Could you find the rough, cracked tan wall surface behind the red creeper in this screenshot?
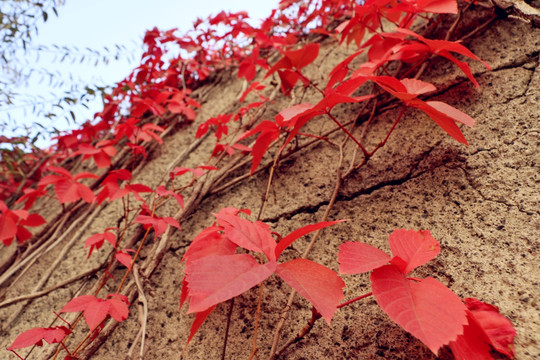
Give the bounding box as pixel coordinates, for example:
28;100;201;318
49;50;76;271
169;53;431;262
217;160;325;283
0;8;540;360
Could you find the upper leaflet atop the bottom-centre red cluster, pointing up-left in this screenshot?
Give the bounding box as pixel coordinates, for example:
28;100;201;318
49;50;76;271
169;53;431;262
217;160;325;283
216;214;276;261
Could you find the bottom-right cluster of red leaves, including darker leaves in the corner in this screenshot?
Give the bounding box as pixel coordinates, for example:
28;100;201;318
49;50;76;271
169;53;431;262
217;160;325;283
338;230;515;359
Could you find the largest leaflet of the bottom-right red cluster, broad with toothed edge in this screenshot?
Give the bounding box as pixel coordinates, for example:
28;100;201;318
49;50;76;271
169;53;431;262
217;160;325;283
370;265;467;354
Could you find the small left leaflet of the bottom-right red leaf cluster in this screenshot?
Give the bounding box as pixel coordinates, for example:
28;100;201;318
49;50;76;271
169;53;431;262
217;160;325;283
338;241;390;274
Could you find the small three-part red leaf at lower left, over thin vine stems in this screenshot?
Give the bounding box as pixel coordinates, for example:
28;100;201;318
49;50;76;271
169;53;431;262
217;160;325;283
60;294;129;331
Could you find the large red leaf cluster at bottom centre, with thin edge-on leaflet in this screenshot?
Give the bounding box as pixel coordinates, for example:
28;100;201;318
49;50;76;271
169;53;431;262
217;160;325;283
181;209;344;341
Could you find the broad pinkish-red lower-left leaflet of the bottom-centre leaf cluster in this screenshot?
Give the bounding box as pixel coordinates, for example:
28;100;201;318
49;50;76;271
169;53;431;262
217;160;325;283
186;254;276;313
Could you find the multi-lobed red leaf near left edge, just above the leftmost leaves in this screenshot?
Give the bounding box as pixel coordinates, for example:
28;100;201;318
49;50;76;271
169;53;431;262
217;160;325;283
38;166;99;204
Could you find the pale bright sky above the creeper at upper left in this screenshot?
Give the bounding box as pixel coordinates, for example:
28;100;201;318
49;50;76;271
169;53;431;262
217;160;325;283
5;0;279;143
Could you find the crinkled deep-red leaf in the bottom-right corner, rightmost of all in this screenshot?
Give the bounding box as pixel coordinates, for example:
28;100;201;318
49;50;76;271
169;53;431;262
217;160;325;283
464;298;516;358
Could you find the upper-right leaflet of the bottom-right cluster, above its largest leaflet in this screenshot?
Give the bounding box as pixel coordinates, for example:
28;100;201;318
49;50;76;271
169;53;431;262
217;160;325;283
388;229;441;275
